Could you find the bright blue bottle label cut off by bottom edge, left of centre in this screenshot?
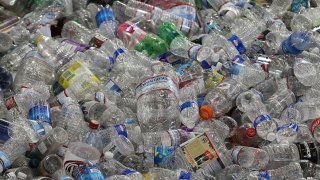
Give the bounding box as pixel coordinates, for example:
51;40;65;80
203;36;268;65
72;165;104;180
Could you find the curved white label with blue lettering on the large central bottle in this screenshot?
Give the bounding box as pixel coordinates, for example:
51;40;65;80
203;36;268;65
136;75;179;99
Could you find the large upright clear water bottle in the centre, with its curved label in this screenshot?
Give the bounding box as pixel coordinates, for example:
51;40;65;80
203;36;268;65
136;66;180;132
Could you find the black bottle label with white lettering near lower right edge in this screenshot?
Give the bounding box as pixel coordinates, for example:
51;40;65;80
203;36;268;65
296;142;318;164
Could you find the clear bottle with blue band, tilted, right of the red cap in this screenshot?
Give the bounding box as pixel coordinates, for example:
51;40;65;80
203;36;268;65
236;90;277;141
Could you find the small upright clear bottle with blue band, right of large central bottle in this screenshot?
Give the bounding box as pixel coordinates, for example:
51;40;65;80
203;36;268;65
179;82;200;128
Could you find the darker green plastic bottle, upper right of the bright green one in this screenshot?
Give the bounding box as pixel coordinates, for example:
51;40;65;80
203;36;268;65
158;22;187;45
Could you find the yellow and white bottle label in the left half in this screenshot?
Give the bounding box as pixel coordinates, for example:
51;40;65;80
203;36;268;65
59;61;100;91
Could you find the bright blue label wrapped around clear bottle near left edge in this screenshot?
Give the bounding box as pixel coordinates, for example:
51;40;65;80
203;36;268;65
29;103;52;124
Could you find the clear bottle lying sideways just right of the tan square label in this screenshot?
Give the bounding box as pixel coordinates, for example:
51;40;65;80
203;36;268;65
231;146;269;170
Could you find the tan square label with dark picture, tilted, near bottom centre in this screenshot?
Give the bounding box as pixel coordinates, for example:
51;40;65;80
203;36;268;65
180;133;225;171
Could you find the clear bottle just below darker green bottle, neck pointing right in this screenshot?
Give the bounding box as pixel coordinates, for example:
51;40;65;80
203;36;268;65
170;37;219;64
